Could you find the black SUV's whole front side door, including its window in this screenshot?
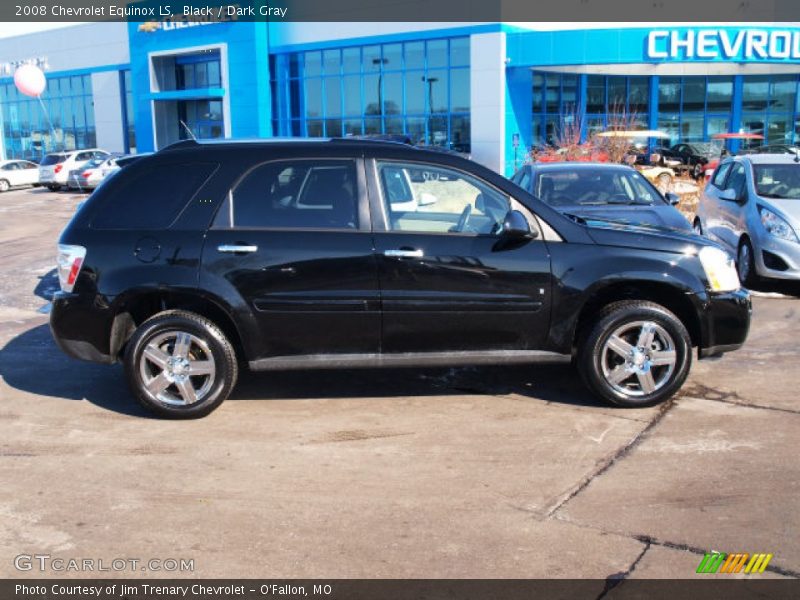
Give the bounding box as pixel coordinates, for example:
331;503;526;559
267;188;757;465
370;160;550;353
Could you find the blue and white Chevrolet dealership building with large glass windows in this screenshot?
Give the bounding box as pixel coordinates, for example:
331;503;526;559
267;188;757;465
0;20;800;174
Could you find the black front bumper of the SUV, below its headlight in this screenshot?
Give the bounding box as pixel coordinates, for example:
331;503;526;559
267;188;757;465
697;289;753;359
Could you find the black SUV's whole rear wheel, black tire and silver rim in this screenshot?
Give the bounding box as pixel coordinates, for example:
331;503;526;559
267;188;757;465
124;310;238;419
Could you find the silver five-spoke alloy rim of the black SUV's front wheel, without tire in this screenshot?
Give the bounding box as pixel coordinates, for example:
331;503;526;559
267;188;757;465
600;321;678;396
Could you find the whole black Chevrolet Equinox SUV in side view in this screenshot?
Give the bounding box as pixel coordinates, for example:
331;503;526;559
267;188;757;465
50;139;750;417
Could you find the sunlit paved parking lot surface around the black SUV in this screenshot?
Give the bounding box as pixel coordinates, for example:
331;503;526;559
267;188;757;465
0;189;800;590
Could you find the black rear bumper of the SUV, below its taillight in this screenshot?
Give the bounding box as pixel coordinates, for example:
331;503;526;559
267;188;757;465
50;292;116;364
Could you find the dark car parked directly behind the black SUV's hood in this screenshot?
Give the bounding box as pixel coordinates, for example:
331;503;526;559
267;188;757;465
512;162;691;232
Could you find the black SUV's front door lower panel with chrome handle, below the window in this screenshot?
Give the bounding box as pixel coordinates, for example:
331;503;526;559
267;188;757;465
375;232;550;352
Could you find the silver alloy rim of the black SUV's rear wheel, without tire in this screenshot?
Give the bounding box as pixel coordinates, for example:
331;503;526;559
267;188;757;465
139;331;217;406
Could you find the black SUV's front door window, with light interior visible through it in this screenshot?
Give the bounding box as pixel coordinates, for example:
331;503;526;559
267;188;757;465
377;161;511;235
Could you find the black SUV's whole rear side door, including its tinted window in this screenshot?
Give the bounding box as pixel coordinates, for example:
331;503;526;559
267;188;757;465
200;160;380;360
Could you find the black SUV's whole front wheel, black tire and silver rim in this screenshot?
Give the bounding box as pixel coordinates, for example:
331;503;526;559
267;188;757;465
577;300;692;408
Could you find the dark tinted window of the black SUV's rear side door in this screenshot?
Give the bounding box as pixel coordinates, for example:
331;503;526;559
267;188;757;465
230;160;358;229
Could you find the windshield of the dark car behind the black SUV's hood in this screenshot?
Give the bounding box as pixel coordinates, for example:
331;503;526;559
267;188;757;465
534;168;663;206
